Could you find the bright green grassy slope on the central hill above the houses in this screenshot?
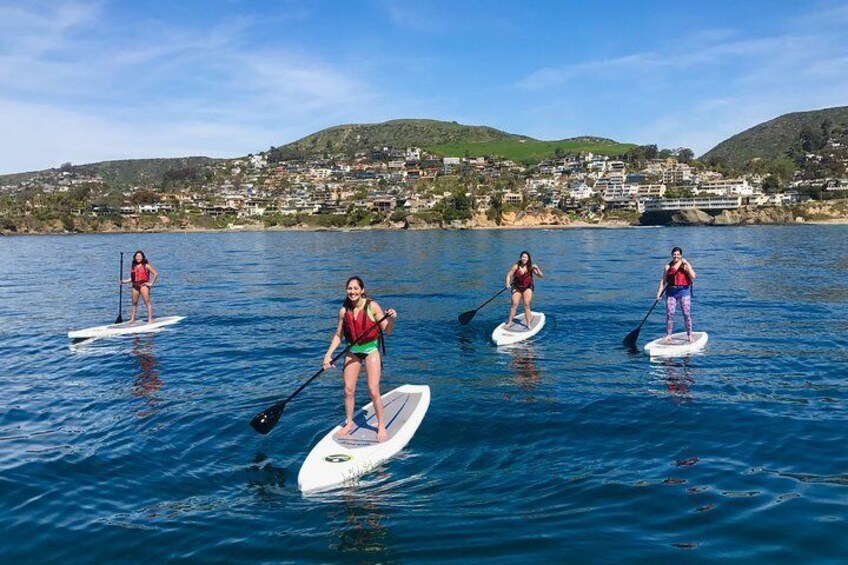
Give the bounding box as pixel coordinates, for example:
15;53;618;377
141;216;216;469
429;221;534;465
426;137;636;161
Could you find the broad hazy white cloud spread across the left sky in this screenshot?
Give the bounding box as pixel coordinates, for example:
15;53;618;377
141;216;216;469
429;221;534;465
0;2;380;172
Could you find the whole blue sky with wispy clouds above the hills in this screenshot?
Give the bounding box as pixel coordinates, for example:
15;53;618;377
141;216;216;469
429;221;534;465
0;0;848;173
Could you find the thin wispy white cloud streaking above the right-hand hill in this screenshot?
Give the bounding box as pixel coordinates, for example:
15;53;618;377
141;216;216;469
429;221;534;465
516;8;848;153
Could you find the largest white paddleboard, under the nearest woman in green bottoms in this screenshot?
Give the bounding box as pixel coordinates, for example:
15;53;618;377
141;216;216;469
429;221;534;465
297;385;430;492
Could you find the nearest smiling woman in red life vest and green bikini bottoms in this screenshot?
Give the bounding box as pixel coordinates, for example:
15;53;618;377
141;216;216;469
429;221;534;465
324;277;397;441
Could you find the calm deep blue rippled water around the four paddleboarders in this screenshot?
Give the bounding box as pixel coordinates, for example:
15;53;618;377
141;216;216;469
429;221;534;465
0;226;848;563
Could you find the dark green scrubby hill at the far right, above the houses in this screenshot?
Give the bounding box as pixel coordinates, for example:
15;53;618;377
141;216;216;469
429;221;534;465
701;106;848;167
